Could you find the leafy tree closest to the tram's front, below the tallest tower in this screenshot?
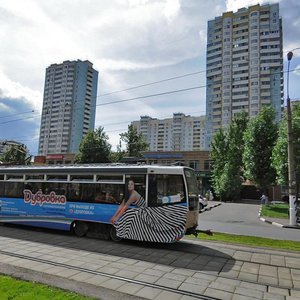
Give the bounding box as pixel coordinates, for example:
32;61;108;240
210;112;248;201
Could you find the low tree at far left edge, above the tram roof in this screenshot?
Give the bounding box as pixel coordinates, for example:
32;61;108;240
0;145;32;165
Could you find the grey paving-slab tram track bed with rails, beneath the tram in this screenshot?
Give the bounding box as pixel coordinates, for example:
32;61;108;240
0;226;300;300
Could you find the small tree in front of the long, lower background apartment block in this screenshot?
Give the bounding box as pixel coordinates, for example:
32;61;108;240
120;124;148;157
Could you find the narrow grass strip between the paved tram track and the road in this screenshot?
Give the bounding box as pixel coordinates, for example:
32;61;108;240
187;232;300;251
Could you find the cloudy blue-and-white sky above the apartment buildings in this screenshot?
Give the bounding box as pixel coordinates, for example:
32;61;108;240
0;0;300;155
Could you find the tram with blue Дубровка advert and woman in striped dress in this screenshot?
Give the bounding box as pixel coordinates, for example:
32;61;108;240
0;164;199;243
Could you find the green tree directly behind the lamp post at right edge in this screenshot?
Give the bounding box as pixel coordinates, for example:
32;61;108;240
272;103;300;185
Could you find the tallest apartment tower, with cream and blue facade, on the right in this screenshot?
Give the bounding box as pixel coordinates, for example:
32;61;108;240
206;4;283;148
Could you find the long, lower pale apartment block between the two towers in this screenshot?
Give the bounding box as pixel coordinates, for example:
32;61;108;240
132;113;205;151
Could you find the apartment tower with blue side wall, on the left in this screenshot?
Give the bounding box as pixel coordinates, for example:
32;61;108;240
38;60;98;155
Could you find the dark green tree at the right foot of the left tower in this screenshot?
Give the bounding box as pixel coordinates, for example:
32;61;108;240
75;126;111;163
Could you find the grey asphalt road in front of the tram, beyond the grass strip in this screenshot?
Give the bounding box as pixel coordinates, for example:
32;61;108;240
198;202;300;241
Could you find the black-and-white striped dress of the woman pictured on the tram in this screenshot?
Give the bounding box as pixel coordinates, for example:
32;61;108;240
116;197;187;243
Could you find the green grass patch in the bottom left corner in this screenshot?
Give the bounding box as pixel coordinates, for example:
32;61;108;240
0;275;93;300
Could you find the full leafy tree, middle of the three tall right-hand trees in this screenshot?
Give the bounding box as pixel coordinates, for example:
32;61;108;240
243;106;278;191
